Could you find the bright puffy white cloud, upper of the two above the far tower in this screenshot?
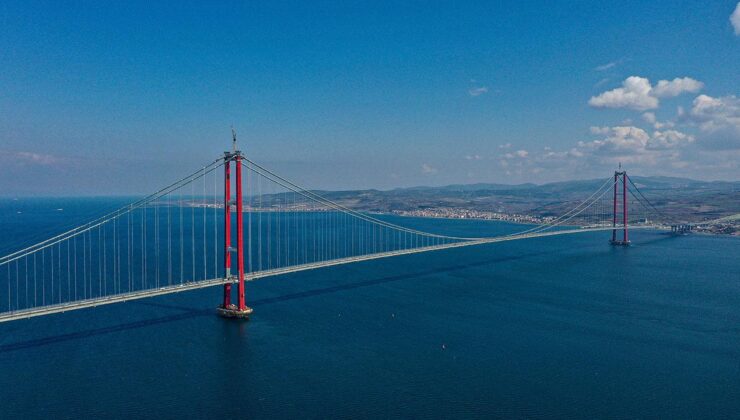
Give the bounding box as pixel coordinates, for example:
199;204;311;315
588;76;704;111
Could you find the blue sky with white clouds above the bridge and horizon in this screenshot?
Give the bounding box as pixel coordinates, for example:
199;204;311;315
0;0;740;196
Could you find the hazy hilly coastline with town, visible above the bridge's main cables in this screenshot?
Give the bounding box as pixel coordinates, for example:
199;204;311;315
306;176;740;221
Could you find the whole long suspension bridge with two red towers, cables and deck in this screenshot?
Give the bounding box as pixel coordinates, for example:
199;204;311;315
0;139;720;322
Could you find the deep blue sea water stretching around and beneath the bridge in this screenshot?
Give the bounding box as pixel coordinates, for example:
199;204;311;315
0;199;740;418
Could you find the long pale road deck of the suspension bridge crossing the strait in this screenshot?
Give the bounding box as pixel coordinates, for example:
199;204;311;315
0;225;665;322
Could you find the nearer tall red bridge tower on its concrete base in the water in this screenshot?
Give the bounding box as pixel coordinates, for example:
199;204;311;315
217;144;252;319
